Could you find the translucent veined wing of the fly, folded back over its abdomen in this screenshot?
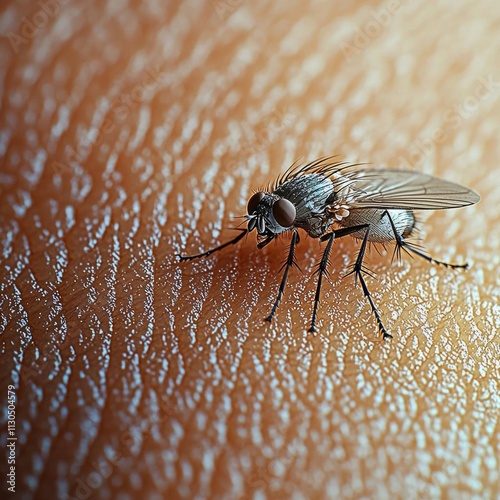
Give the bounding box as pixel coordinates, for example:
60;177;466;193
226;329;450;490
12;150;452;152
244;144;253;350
339;169;479;210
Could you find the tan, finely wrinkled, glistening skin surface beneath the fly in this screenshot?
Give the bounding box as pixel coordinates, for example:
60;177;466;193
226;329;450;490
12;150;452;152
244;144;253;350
0;0;500;498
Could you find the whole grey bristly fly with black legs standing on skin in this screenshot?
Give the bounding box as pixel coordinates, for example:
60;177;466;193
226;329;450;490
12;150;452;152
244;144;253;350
178;157;479;339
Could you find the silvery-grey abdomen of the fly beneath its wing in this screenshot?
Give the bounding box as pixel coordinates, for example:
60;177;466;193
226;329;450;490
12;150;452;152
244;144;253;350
340;208;415;243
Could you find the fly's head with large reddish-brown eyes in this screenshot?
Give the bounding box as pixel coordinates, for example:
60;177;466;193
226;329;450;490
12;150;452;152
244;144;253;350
246;191;297;240
